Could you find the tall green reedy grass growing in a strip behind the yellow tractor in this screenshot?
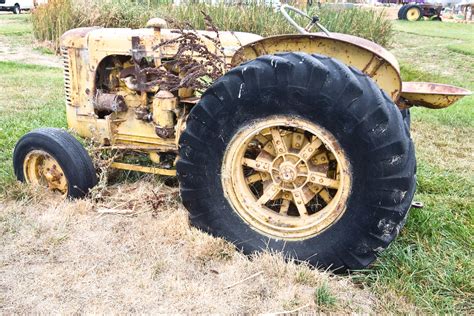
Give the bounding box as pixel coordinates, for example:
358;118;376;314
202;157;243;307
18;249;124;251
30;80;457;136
32;0;393;49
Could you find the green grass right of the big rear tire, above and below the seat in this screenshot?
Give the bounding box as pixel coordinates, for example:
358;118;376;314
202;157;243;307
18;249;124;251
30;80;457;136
356;21;474;314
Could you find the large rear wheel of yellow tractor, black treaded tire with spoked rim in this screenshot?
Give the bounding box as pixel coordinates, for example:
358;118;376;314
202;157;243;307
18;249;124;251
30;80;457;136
177;53;416;271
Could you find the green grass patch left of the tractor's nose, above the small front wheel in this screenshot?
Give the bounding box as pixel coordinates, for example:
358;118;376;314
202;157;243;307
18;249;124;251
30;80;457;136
0;62;66;193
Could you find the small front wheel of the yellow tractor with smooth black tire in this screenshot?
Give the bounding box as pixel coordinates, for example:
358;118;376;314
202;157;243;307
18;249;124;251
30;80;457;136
13;128;97;198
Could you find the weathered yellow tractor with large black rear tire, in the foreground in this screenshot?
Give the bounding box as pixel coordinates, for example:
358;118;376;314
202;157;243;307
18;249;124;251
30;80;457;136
14;5;470;270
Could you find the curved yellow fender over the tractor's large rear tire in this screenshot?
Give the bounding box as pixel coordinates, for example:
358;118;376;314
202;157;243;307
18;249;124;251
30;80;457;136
231;33;402;102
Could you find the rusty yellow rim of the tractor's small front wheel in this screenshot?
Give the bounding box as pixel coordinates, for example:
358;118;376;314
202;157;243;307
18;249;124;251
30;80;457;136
23;150;68;194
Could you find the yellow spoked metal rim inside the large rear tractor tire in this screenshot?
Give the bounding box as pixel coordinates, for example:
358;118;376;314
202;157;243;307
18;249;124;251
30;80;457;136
222;117;351;240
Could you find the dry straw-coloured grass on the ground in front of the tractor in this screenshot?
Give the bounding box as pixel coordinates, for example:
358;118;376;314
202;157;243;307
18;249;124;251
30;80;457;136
0;182;402;313
